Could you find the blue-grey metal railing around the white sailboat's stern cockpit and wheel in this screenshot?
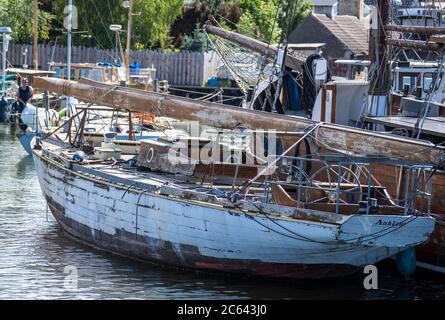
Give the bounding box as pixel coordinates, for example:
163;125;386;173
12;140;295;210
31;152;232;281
264;155;433;215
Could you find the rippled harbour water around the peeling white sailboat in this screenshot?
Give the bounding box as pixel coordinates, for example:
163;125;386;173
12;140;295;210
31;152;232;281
0;124;445;299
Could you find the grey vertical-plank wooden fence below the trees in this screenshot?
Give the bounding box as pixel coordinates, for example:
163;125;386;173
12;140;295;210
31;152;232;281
3;43;218;86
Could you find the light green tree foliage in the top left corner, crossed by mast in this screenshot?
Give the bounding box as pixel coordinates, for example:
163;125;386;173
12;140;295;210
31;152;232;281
0;0;55;43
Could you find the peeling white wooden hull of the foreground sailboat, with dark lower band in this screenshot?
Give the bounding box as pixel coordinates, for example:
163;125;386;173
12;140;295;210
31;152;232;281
34;146;434;279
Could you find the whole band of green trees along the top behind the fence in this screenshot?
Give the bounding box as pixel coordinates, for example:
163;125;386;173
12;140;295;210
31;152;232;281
0;0;312;51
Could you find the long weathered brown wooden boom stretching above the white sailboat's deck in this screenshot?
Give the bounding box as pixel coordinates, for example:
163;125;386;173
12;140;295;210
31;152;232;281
34;78;445;164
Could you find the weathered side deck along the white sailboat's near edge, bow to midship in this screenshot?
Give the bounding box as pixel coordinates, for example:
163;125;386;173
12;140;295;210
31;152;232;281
35;143;349;225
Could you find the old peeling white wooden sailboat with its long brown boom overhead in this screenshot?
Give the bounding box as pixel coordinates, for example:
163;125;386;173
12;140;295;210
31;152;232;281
29;78;444;278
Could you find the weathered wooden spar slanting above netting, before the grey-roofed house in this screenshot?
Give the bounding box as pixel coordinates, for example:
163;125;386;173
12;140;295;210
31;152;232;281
204;25;306;71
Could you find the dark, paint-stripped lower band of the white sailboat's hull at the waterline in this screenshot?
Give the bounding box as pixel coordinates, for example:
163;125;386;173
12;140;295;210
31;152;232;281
47;198;358;279
